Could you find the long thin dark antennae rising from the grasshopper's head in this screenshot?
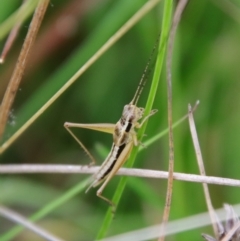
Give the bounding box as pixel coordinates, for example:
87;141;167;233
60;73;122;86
130;35;160;105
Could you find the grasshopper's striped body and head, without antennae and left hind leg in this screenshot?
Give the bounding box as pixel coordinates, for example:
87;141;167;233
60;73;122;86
86;102;157;205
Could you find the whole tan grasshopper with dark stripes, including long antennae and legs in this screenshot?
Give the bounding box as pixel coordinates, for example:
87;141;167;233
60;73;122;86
64;50;157;206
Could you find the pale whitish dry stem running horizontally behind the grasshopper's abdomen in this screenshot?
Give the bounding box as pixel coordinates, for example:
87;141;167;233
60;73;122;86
0;164;240;187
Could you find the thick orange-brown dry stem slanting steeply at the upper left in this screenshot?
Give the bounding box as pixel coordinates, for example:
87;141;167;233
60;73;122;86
0;0;49;139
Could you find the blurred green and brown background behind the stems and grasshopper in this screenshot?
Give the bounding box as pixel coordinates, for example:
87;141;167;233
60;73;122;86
0;0;240;241
